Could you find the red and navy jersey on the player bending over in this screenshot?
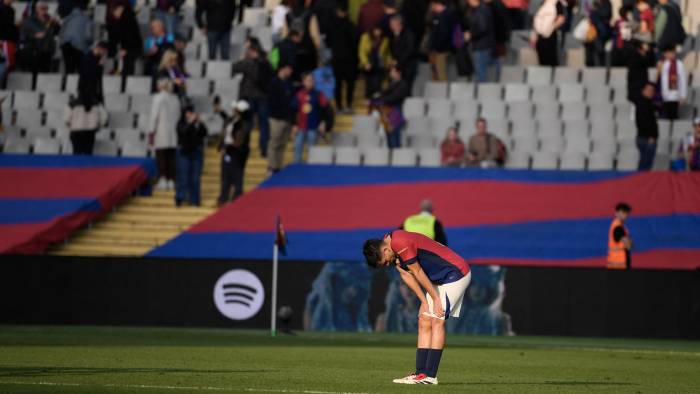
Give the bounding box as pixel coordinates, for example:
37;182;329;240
391;230;469;285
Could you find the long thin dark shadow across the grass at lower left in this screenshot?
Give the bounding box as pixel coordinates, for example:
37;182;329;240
0;366;276;377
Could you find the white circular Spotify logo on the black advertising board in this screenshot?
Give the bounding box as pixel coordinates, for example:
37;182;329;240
214;270;265;320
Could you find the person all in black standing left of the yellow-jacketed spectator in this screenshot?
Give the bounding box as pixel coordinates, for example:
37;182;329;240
329;6;358;114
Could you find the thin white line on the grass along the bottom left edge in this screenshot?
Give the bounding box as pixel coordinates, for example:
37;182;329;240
0;381;368;394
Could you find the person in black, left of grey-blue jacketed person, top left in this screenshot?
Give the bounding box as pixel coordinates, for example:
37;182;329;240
20;1;59;73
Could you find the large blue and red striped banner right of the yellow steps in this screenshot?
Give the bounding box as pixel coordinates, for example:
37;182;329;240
150;165;700;269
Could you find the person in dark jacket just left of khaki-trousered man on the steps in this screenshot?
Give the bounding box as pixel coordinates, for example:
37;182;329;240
233;44;273;157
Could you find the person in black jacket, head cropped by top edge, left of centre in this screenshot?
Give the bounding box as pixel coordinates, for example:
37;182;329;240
195;0;236;60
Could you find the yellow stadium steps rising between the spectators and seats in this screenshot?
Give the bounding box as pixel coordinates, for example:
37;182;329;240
47;88;367;256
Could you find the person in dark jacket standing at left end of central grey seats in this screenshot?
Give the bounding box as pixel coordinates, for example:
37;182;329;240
373;66;411;149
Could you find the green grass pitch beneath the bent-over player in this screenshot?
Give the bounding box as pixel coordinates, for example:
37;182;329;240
0;326;700;394
